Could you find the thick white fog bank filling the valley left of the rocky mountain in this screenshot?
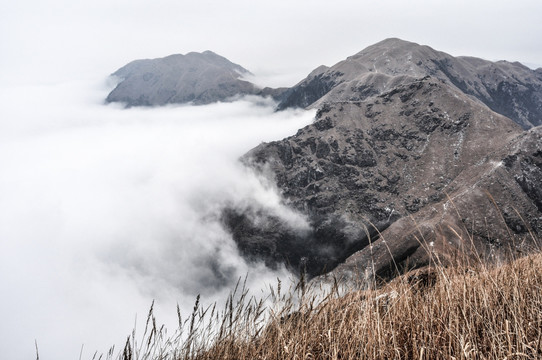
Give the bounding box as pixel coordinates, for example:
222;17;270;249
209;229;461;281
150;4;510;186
0;82;314;359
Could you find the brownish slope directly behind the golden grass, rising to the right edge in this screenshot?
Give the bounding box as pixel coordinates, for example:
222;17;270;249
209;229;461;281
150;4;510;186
332;126;542;278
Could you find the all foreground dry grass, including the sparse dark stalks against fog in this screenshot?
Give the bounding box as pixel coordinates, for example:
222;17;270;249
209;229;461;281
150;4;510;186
107;248;542;360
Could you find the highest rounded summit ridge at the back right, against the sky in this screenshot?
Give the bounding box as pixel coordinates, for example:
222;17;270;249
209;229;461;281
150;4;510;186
279;39;542;129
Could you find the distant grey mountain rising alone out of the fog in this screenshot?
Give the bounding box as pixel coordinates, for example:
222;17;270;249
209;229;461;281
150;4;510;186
106;51;268;107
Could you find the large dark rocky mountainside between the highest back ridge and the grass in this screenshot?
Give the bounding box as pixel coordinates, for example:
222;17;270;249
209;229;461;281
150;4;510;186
224;75;542;276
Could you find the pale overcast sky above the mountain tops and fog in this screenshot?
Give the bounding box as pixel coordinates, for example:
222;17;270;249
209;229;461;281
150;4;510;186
0;0;542;85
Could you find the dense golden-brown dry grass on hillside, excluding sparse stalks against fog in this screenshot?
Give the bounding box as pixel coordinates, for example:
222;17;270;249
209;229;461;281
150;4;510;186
196;256;542;359
